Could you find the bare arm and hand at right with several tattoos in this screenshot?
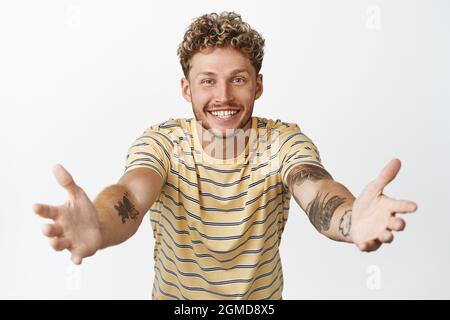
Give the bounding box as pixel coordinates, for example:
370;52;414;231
287;159;417;251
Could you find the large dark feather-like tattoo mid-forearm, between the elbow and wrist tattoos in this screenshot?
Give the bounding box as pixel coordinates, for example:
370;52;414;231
306;193;345;232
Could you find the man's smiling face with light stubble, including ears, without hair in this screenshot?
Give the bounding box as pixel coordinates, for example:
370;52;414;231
181;47;263;137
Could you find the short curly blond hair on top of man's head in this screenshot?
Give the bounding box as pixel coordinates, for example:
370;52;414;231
177;12;264;78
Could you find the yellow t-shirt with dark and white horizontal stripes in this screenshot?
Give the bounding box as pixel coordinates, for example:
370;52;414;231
125;117;322;299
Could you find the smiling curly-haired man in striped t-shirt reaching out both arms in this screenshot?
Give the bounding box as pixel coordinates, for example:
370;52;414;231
33;12;417;299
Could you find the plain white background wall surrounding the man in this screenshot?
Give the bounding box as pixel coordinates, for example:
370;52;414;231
0;0;450;299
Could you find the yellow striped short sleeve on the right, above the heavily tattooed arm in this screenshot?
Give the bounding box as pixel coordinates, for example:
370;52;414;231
280;124;323;187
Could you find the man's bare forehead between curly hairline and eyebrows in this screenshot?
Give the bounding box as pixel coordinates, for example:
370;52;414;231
190;47;254;77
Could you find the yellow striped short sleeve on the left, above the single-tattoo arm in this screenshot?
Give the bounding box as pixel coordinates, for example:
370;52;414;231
125;127;173;183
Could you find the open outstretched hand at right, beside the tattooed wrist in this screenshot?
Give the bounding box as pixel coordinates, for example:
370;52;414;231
350;159;417;251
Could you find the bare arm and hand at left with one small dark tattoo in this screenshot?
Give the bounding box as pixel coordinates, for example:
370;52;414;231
33;165;162;264
